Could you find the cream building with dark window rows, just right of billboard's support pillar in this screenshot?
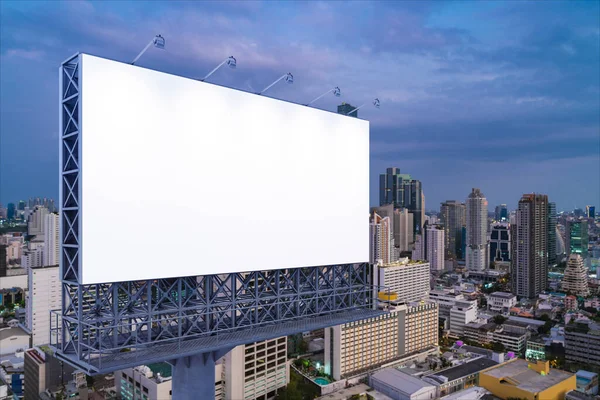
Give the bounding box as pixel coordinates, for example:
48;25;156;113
223;337;290;399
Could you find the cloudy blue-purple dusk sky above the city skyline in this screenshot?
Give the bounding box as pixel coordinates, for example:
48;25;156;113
0;0;600;210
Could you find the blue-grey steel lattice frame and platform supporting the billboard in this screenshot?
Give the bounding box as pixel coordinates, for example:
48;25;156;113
56;54;381;373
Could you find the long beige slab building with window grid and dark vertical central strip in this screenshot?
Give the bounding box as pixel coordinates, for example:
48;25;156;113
324;301;438;380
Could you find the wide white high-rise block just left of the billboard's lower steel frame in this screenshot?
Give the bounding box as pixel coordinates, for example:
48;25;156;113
25;265;61;346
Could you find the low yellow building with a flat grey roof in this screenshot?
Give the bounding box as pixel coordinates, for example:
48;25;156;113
479;359;577;400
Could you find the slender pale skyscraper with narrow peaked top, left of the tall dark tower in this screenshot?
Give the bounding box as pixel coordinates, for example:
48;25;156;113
465;188;489;271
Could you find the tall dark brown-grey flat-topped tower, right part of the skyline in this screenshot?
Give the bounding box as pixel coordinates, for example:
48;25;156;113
511;194;548;298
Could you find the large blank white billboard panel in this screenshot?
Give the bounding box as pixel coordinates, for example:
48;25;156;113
80;55;369;284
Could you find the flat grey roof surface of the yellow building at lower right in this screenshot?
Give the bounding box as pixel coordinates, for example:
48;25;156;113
484;358;573;393
